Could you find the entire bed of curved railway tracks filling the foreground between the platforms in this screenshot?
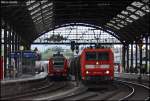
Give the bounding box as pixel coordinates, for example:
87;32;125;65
2;80;150;101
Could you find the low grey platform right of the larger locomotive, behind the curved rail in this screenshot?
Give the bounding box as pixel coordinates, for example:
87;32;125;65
114;72;150;81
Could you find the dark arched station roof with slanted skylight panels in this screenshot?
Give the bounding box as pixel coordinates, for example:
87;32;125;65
1;0;150;43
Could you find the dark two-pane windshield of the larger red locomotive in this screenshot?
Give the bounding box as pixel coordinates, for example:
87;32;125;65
86;52;109;60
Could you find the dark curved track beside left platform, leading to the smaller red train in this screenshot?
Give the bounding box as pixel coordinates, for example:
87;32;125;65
1;81;70;100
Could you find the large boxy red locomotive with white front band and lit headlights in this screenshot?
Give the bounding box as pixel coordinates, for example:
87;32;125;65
80;48;114;81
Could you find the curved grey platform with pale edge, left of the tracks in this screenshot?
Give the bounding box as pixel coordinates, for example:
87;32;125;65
1;72;48;98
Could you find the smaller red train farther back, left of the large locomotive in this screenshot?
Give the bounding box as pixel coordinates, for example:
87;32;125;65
48;52;68;79
